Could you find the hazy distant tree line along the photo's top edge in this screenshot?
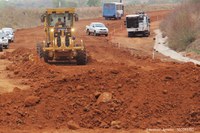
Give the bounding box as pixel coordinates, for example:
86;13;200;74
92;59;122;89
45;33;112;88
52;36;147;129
0;0;183;8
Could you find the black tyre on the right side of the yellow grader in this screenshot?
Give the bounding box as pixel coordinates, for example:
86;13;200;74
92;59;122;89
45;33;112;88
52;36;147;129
76;50;87;65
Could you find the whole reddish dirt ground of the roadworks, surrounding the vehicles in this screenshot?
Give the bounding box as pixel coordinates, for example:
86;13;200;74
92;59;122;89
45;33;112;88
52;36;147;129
0;11;200;133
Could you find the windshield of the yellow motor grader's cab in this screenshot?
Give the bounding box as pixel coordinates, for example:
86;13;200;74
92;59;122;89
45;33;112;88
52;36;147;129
48;13;73;28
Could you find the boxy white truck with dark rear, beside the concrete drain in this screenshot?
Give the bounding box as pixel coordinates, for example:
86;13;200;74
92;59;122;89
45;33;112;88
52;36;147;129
125;12;150;37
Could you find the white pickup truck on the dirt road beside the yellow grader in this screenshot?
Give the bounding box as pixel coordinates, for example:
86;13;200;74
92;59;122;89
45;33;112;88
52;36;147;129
86;22;109;36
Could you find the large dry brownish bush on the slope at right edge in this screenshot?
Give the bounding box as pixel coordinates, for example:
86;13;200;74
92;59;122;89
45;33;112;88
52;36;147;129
161;0;200;51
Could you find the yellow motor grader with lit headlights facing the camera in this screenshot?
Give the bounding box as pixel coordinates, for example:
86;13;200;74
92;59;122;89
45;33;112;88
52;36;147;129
37;8;87;65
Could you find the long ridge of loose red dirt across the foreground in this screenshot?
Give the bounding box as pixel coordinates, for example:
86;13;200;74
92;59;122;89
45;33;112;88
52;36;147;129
0;49;200;129
